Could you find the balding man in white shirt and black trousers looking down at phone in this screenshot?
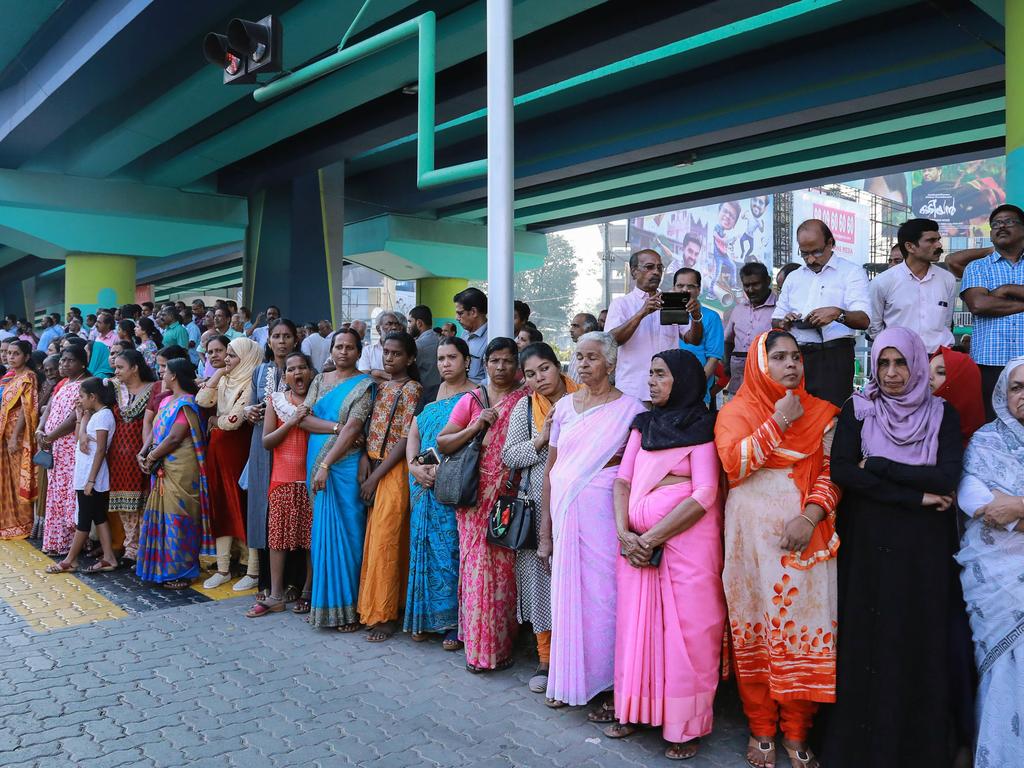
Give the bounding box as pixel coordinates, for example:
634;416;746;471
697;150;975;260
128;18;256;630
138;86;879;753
772;219;870;408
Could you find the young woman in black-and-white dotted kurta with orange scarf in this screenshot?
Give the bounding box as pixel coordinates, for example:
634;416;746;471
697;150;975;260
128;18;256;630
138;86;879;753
502;342;580;693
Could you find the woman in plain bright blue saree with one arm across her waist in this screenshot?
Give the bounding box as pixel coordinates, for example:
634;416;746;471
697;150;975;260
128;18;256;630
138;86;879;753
301;330;373;632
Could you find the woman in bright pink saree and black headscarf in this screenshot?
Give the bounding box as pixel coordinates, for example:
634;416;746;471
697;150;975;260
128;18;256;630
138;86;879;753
604;349;725;760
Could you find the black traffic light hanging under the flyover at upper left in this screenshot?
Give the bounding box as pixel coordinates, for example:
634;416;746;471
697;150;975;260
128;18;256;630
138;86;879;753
203;16;282;85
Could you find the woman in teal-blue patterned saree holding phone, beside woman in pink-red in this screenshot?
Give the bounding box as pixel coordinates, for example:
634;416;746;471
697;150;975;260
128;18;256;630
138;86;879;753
403;337;474;650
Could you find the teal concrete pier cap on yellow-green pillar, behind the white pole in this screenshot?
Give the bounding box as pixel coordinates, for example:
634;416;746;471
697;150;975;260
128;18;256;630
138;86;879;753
345;215;548;280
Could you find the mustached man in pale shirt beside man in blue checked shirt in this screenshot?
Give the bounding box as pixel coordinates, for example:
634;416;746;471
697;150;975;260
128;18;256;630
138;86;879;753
868;219;956;353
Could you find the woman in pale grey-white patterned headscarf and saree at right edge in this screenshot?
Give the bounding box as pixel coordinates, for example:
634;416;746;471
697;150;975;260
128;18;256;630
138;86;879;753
956;357;1024;768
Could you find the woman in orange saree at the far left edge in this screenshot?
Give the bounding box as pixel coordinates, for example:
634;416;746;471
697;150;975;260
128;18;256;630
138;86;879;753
0;341;39;539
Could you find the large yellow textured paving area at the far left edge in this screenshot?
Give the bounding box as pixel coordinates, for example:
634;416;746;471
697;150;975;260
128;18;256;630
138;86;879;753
0;541;128;632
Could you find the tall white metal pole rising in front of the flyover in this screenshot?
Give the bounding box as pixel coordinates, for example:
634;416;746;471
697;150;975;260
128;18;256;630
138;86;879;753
487;0;514;339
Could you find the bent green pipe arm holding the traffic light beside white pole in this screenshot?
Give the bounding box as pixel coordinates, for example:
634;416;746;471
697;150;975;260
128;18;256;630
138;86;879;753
253;11;487;189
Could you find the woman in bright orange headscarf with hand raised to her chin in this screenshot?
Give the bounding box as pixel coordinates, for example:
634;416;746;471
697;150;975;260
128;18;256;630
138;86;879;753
715;331;839;768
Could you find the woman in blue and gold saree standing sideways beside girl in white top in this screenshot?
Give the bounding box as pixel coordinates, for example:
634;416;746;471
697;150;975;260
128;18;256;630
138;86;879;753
135;359;216;589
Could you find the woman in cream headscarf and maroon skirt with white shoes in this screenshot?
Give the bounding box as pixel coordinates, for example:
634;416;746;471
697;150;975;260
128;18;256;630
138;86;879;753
196;338;263;591
